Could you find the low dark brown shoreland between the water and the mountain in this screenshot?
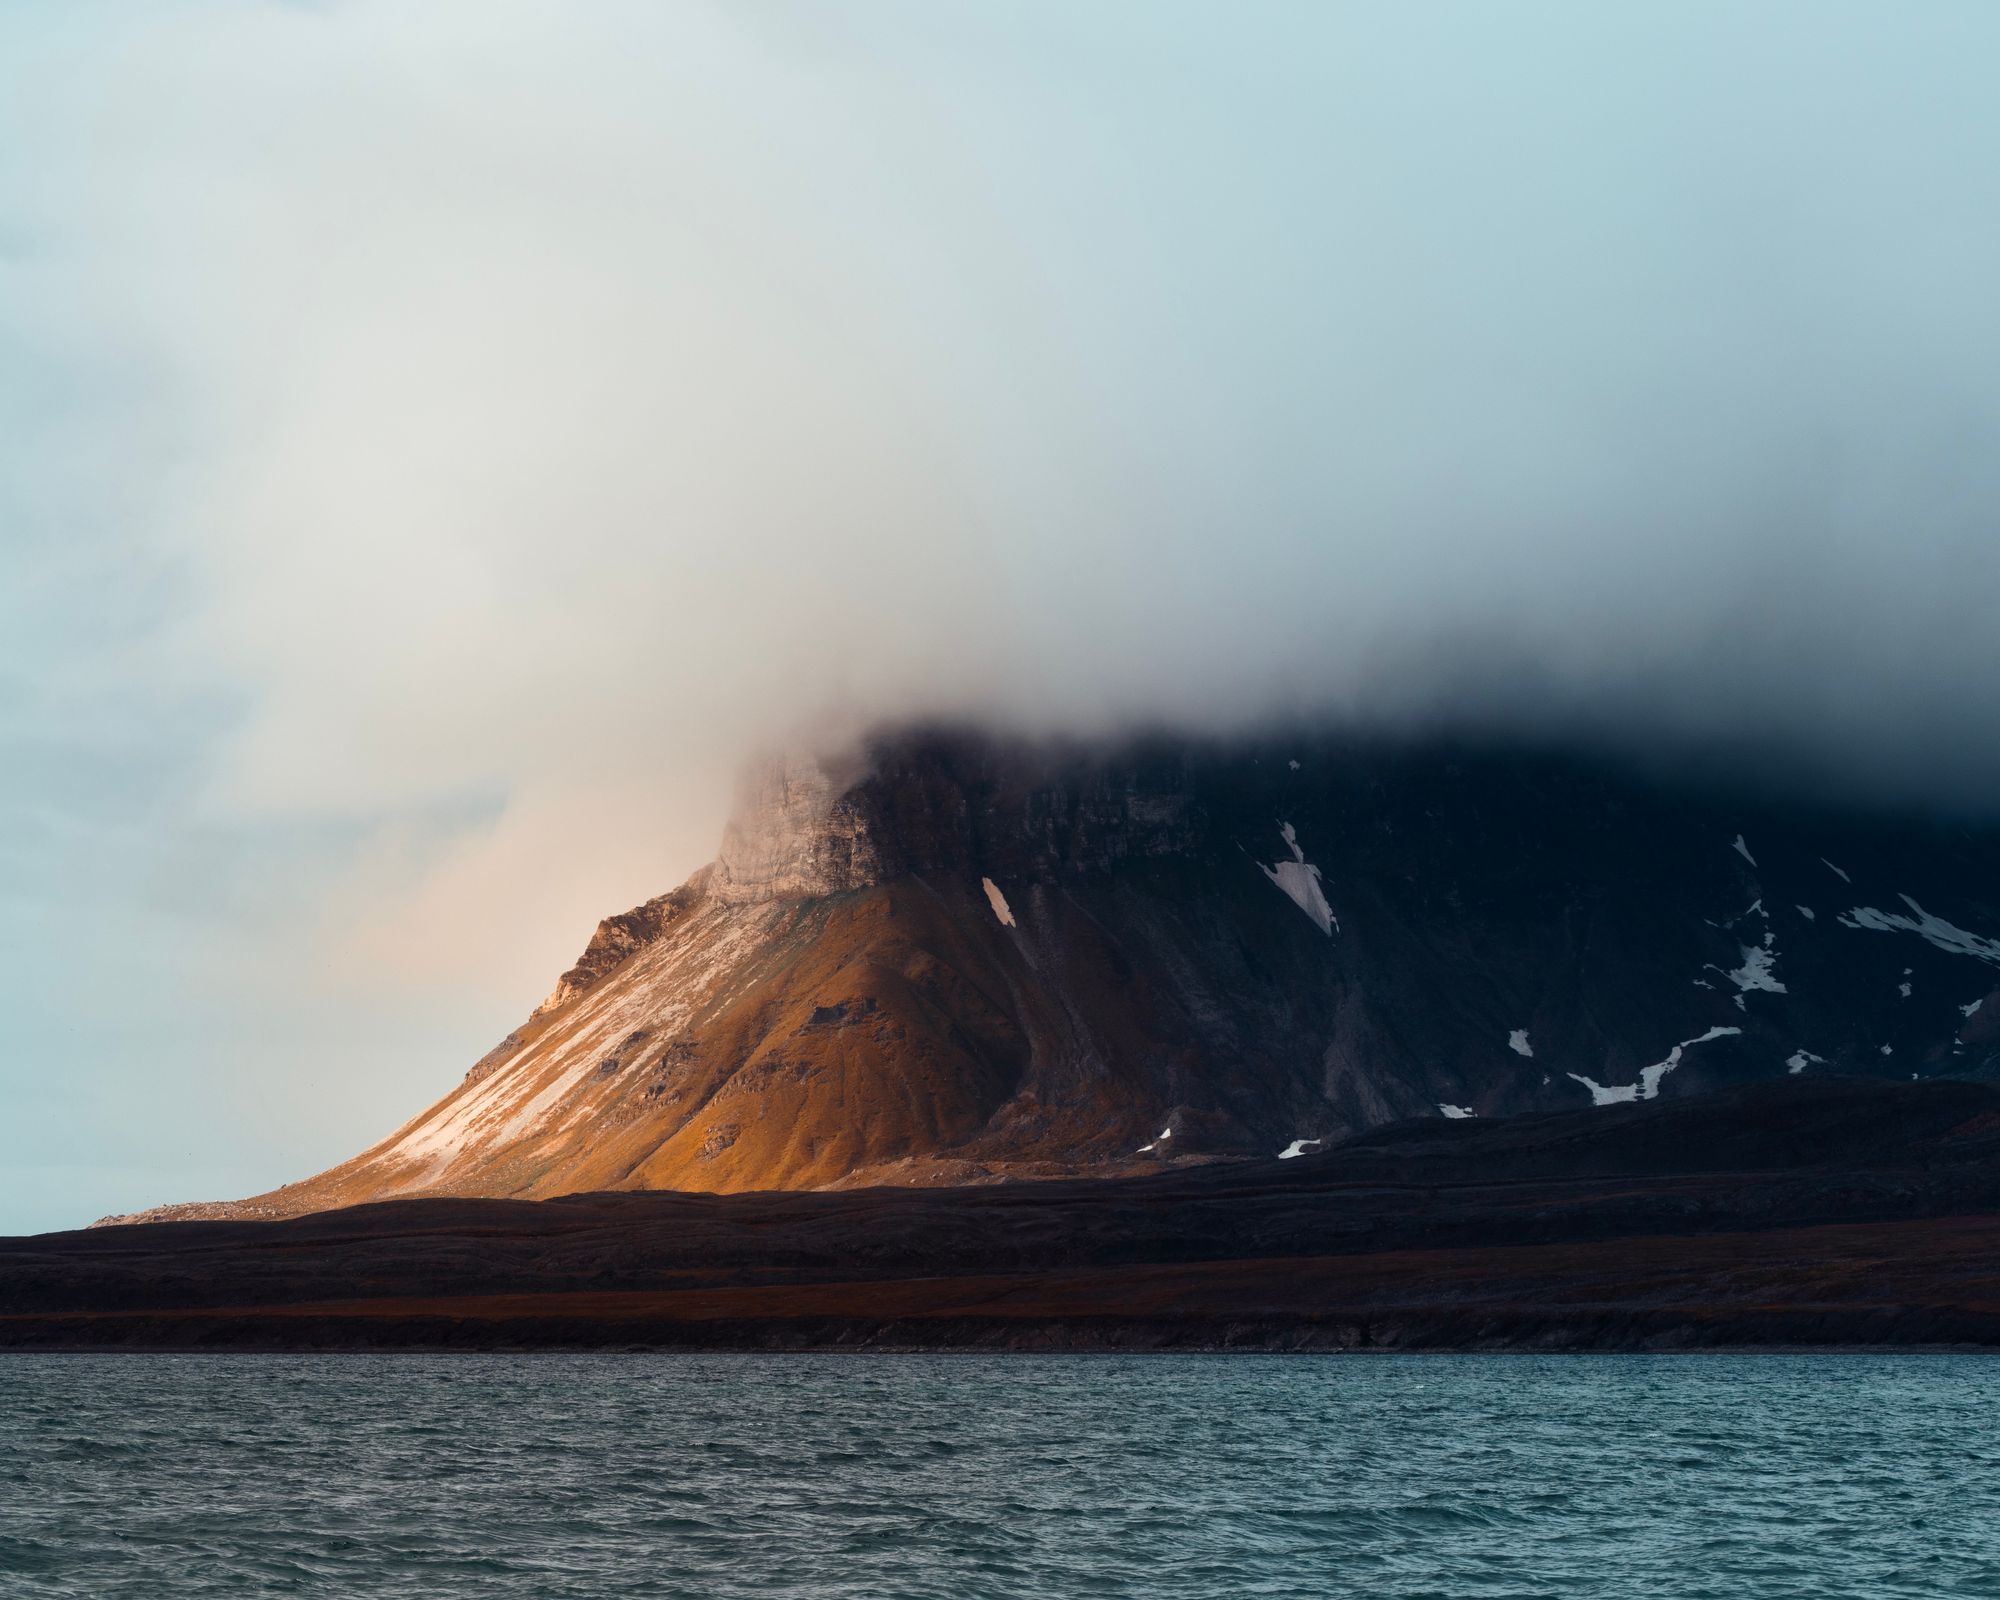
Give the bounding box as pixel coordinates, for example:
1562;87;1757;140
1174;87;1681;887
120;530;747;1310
11;1080;2000;1350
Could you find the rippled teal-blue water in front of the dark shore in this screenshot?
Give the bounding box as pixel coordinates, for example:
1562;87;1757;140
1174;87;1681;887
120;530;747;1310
0;1356;2000;1600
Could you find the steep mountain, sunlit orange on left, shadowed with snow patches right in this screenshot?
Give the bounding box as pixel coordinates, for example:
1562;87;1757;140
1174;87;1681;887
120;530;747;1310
108;728;2000;1220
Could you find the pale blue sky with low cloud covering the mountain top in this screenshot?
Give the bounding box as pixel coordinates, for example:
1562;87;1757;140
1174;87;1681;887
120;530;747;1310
0;0;2000;1226
